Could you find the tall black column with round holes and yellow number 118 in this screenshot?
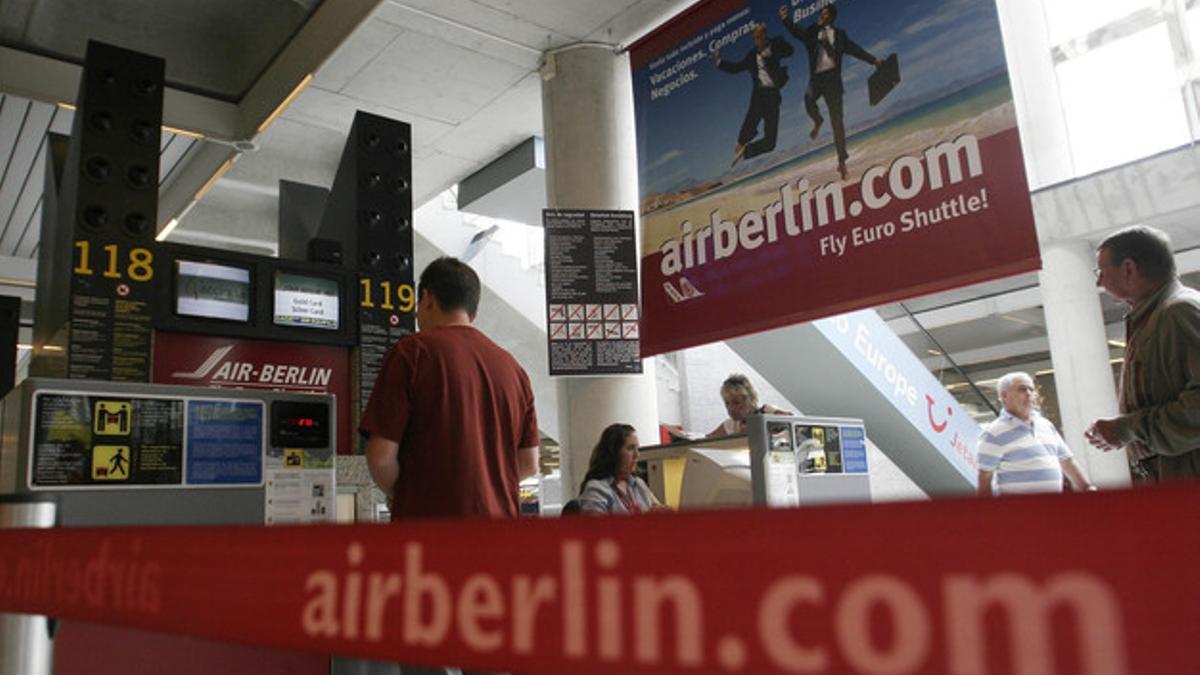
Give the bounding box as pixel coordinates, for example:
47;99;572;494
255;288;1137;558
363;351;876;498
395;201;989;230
54;41;164;382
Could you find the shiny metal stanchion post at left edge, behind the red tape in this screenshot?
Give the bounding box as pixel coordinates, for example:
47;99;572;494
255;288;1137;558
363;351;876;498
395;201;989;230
0;495;58;675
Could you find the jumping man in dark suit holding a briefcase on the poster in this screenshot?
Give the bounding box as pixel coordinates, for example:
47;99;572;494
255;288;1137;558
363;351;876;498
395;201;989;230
779;5;883;179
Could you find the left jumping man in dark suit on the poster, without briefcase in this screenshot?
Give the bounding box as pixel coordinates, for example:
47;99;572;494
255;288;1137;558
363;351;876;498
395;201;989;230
713;24;794;167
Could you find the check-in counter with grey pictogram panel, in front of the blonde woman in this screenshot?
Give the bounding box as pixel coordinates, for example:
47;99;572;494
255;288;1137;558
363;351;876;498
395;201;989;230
640;414;871;509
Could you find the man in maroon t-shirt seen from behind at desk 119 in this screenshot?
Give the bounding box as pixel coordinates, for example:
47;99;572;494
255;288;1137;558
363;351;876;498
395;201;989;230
359;257;539;520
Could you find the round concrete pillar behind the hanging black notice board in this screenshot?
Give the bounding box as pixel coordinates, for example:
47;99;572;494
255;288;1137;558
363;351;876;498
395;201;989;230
541;44;659;498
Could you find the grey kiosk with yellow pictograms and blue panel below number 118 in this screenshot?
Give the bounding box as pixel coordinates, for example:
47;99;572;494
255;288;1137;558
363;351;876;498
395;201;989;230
0;378;336;675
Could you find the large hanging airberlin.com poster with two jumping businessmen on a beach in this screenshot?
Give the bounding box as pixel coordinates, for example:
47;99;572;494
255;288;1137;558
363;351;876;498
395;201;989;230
630;0;1040;356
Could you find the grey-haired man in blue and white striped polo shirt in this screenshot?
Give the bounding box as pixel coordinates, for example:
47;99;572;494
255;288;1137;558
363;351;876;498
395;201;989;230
976;372;1096;497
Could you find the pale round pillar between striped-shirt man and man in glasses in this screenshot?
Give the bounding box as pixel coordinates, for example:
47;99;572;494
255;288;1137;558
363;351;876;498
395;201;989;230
1040;239;1129;488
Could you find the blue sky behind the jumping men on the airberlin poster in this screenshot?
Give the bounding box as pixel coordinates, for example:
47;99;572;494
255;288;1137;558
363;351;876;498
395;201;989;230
634;0;1006;198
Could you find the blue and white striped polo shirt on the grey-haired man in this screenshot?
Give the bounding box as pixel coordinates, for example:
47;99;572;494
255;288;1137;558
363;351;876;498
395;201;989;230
976;411;1072;495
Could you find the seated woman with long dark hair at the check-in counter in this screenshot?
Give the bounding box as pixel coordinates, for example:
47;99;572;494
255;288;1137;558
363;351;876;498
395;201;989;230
578;424;667;514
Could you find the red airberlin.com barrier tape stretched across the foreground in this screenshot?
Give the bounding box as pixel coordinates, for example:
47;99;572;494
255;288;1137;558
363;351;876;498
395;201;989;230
0;485;1200;675
